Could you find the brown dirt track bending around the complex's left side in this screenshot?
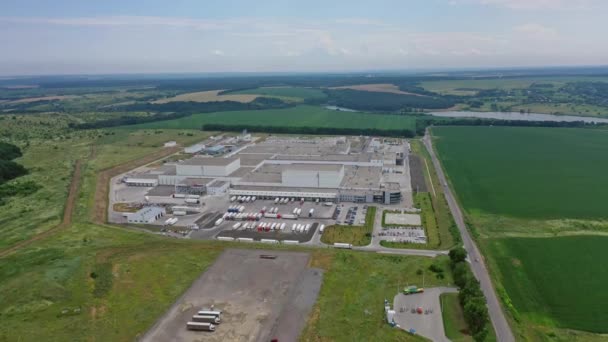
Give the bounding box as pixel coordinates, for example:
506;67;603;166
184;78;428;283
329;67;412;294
91;146;181;224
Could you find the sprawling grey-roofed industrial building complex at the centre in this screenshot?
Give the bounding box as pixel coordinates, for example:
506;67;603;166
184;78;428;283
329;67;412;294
125;137;411;204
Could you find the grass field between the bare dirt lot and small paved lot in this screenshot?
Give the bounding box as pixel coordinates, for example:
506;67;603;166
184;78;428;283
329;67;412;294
300;251;453;341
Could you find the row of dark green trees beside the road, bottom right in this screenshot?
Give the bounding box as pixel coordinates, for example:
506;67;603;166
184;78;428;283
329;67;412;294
449;247;490;341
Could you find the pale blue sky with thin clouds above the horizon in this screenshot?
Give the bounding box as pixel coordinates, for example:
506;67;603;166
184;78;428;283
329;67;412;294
0;0;608;75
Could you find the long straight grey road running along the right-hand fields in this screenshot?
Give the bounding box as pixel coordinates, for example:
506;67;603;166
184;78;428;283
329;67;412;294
422;129;515;342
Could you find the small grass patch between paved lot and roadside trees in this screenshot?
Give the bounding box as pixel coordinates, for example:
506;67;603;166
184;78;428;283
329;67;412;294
440;293;476;342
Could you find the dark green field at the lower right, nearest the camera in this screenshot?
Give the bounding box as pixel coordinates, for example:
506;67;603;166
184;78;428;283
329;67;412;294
489;236;608;333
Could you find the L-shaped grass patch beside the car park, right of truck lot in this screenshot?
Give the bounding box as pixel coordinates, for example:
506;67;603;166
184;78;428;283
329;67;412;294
321;207;376;246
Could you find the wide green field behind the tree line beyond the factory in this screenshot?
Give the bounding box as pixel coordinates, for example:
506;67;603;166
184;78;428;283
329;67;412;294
128;106;415;130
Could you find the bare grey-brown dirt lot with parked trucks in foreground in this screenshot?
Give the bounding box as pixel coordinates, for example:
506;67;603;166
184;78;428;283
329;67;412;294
142;249;322;342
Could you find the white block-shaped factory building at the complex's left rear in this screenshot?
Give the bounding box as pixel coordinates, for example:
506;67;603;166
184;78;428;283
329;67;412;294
176;157;241;177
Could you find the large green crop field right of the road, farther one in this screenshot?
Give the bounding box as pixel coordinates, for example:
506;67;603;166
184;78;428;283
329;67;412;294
433;127;608;219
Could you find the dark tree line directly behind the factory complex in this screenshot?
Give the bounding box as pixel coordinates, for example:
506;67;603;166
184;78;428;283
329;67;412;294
201;124;415;138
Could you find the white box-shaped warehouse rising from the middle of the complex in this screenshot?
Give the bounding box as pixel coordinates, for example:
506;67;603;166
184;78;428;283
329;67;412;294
281;164;344;188
